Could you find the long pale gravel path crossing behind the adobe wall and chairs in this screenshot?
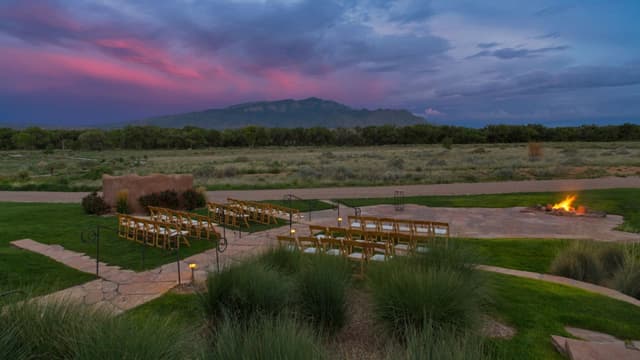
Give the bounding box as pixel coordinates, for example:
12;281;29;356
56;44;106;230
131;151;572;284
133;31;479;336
0;176;640;203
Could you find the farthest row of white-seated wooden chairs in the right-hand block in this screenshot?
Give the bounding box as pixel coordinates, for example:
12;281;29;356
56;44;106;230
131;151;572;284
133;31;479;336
347;216;450;238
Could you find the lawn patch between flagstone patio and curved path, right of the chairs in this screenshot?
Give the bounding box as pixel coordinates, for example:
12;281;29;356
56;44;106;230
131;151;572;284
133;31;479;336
453;238;572;273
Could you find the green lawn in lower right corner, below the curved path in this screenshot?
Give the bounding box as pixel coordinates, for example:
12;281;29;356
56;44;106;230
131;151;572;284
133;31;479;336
488;274;640;360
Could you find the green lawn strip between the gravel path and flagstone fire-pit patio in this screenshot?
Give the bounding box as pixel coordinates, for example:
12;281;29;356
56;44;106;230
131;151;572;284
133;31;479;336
335;189;640;232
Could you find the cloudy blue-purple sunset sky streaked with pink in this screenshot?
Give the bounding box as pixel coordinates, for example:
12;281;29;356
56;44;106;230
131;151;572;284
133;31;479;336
0;0;640;126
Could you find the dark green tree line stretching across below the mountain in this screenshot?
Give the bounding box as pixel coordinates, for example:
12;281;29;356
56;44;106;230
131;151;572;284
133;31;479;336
0;124;640;150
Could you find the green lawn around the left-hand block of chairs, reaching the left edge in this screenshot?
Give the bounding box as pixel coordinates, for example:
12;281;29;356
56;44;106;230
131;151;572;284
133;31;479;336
0;203;215;272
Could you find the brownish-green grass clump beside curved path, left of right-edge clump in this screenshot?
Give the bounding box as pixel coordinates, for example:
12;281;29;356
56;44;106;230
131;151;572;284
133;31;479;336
550;242;603;284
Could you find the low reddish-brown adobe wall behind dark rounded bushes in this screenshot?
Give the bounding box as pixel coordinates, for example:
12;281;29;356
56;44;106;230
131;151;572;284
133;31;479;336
102;174;193;214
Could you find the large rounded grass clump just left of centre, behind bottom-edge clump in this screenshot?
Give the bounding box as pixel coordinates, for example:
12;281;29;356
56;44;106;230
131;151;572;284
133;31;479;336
201;261;293;320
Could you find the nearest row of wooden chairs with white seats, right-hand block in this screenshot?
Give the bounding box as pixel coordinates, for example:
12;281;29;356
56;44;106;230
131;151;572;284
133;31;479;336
277;236;393;276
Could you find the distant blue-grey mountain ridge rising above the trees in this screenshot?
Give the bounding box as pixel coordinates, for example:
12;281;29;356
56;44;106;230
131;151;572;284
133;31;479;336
133;97;425;129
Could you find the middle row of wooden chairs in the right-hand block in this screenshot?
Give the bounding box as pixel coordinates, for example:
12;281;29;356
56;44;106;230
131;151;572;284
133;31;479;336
309;225;440;255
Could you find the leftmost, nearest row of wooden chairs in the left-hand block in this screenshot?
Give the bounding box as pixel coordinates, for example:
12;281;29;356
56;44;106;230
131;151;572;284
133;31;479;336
118;214;191;249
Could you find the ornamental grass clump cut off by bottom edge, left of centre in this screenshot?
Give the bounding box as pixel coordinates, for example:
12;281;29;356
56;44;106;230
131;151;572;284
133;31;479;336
207;316;328;360
